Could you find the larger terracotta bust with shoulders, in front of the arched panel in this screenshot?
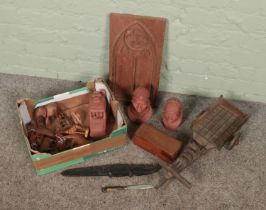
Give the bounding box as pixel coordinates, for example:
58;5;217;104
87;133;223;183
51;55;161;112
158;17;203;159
127;87;152;122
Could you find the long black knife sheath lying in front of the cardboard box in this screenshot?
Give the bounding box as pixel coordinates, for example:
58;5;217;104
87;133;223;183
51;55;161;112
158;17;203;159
61;164;161;177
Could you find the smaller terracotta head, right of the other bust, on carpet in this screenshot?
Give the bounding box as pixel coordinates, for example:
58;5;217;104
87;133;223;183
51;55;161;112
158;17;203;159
162;98;183;131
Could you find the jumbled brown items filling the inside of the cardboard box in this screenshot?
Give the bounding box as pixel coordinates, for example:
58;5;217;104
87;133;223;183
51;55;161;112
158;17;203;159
26;91;109;154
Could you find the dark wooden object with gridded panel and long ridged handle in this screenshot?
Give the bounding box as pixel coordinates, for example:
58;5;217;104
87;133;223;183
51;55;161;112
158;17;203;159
157;96;249;187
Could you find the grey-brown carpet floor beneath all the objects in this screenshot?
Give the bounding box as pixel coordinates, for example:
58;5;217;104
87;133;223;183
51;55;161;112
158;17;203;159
0;74;266;210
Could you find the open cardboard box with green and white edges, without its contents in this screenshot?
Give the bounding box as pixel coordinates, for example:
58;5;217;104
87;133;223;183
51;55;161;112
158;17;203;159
17;79;128;175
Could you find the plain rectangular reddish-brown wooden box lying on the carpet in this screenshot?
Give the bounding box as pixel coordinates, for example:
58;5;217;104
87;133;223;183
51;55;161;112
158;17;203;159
133;123;182;163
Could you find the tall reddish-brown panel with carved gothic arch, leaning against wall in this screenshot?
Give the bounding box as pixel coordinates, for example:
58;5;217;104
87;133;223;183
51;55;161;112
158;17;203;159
109;14;166;104
